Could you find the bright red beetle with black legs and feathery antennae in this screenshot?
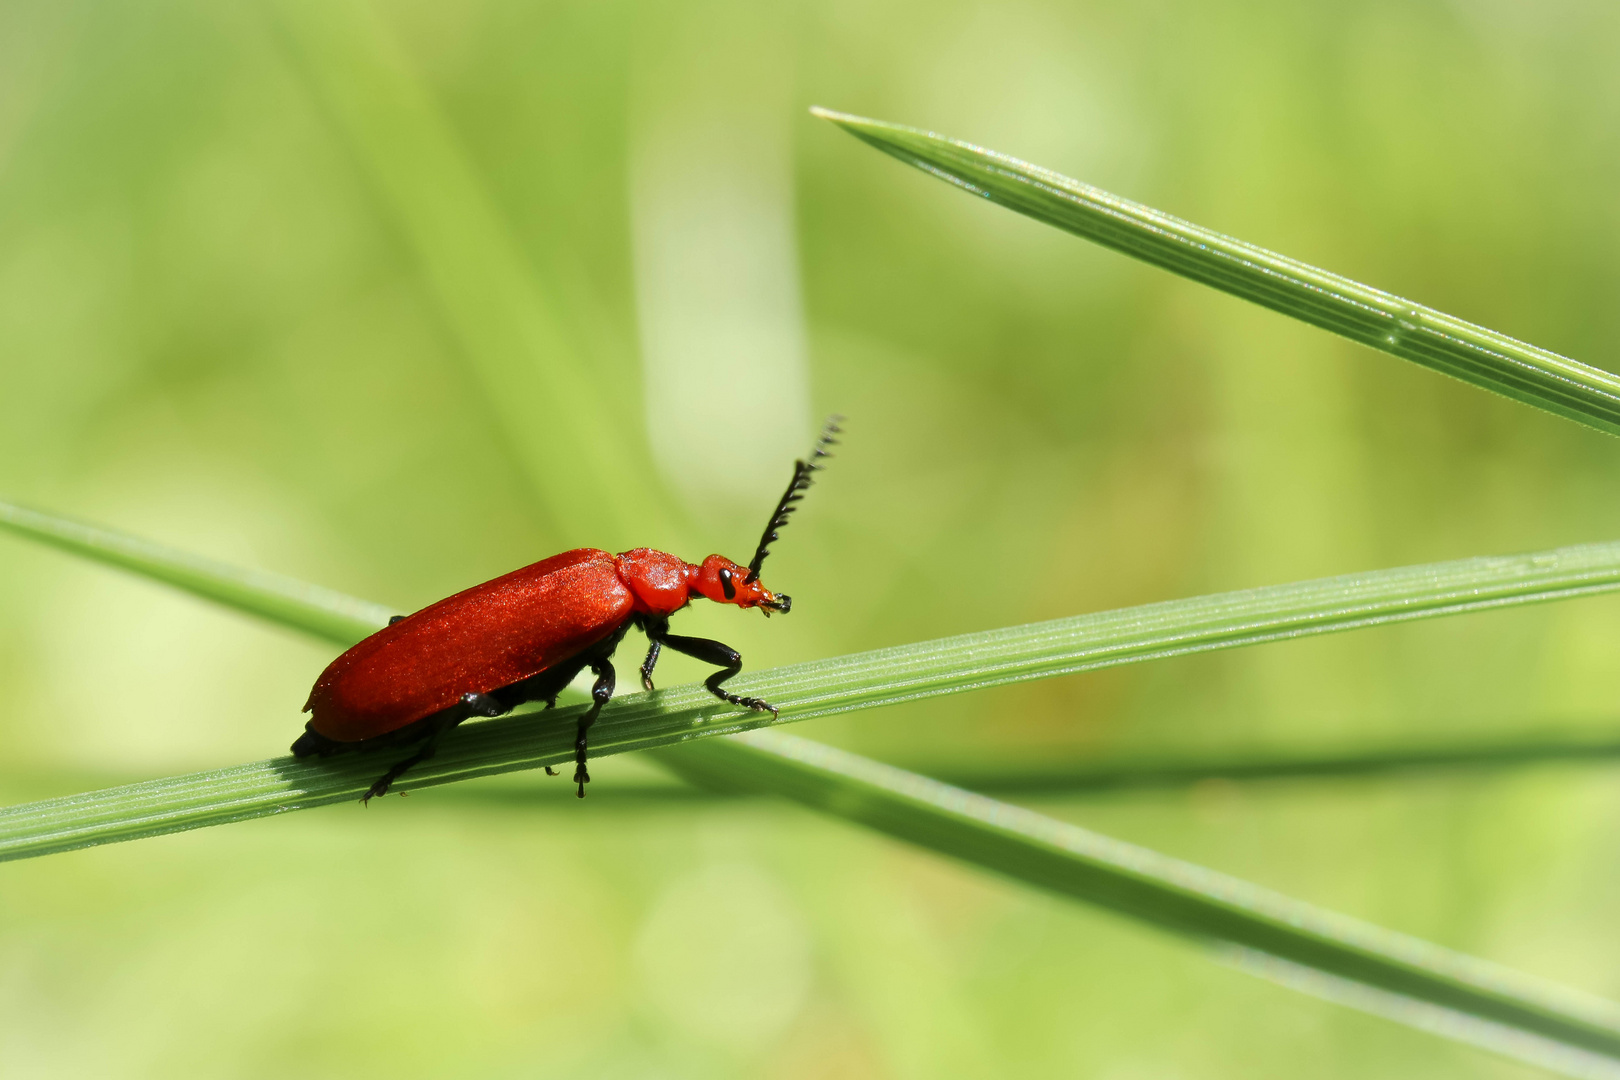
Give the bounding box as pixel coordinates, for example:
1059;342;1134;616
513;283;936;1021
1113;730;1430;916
292;416;842;801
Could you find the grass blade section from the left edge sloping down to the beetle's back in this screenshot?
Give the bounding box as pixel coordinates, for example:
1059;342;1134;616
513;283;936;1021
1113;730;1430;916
0;502;394;644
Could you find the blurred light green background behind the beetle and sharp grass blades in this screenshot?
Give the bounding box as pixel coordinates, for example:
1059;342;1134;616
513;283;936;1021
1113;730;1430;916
0;0;1620;1080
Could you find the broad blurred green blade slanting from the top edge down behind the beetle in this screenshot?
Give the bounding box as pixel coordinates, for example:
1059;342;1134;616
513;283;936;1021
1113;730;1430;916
269;0;663;537
